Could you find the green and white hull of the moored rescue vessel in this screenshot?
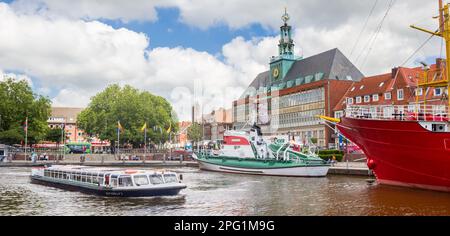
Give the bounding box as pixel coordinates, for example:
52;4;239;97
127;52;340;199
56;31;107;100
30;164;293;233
197;159;330;177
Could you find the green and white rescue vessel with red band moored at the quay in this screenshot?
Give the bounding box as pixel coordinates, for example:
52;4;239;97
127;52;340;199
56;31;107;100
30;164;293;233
193;125;330;177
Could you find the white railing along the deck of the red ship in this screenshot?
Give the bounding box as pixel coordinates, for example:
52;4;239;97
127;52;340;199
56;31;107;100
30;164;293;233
345;105;449;122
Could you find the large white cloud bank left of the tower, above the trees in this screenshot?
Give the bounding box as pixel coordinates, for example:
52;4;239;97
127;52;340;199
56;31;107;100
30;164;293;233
0;3;250;119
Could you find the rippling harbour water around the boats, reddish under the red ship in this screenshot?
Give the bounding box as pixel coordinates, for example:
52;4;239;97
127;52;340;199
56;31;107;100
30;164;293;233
0;168;450;216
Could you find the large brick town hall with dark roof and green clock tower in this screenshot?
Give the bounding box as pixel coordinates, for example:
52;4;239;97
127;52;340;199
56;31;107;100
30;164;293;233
233;10;364;147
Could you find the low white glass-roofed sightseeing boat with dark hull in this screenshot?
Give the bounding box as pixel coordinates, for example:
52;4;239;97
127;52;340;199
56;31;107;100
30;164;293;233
31;166;186;197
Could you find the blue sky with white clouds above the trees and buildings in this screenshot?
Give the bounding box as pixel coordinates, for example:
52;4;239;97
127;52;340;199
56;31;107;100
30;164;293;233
0;0;445;120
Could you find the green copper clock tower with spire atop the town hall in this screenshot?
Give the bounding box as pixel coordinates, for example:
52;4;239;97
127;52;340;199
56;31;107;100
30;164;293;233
270;9;301;84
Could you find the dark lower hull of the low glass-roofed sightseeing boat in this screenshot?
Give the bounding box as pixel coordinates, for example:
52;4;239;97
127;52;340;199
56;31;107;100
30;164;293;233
31;176;186;197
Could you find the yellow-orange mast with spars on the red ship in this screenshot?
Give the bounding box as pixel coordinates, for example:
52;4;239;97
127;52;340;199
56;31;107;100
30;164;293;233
411;0;450;117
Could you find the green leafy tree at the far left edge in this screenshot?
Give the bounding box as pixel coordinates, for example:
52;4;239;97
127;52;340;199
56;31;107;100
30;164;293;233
0;78;51;144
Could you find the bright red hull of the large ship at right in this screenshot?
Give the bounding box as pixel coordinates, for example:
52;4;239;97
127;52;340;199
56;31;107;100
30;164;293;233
337;117;450;192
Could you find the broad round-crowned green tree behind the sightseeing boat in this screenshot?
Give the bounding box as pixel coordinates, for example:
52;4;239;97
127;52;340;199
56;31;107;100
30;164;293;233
77;85;178;147
